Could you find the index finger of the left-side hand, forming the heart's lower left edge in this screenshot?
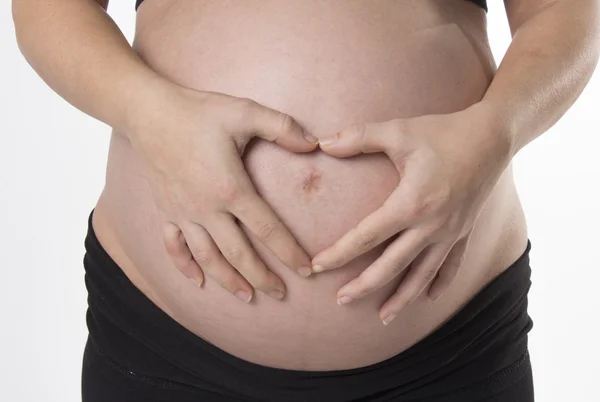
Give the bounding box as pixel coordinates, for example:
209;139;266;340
230;192;311;276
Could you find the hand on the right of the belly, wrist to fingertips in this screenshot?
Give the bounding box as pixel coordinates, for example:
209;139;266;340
312;106;510;324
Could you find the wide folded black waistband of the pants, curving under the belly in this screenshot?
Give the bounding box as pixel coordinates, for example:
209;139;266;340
84;212;532;402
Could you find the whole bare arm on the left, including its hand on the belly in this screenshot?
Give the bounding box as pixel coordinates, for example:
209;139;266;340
13;0;316;302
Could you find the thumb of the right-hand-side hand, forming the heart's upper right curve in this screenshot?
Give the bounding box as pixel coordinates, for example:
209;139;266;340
319;120;401;158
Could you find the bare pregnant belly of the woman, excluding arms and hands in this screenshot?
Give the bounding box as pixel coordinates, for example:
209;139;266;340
93;0;527;370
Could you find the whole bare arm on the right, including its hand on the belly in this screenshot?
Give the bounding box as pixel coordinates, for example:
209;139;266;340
312;0;600;324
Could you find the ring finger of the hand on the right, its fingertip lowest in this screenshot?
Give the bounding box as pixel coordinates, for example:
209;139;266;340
380;243;451;325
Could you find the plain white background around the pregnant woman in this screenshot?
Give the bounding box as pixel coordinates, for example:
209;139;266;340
0;0;600;402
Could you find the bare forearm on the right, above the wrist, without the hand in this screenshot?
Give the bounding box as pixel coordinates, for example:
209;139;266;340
481;0;599;156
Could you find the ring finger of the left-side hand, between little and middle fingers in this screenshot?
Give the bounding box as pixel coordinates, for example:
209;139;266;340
181;222;253;302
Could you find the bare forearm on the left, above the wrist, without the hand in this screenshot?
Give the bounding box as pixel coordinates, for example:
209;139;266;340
13;0;164;135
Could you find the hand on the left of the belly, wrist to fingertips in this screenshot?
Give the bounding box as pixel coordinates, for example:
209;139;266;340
129;83;317;302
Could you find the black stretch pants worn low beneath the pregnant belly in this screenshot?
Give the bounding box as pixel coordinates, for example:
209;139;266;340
82;215;534;402
